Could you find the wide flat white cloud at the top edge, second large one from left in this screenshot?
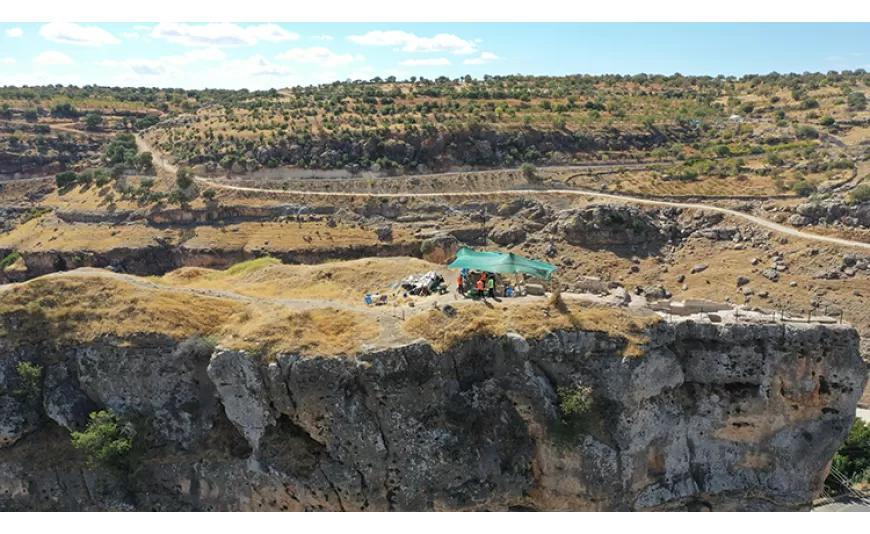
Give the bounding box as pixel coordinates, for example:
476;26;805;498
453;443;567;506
151;22;299;46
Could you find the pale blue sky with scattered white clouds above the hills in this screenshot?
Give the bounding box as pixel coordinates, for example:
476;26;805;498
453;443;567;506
0;22;870;90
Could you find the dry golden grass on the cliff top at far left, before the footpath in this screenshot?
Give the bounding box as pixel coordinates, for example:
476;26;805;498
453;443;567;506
0;276;380;355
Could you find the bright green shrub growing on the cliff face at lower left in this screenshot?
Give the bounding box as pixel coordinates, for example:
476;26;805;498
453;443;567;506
72;410;136;472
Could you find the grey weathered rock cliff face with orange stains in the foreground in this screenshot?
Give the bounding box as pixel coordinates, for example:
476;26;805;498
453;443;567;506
0;316;867;511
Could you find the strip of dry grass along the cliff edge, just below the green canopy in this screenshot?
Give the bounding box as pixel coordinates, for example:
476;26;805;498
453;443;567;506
405;302;659;356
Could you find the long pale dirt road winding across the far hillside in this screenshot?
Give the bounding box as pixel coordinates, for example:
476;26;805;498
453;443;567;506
136;136;870;250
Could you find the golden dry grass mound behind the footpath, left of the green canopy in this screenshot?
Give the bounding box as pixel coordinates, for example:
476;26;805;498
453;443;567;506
155;258;446;303
